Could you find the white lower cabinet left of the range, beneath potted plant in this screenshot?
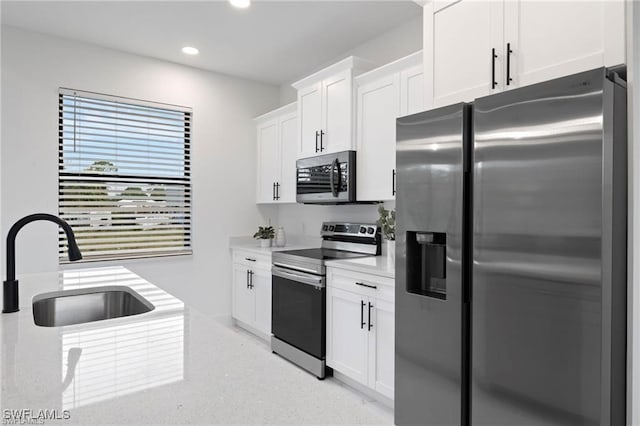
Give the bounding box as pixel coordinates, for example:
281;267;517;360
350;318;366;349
231;250;271;337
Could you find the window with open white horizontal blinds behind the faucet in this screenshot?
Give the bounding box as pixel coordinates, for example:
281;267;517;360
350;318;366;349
58;89;191;262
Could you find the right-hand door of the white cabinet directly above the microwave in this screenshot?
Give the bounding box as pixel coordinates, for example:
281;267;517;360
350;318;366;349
320;70;353;153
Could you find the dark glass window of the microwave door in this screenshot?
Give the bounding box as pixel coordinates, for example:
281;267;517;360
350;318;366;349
297;162;349;194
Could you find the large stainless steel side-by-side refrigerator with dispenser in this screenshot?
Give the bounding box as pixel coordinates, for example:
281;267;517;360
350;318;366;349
395;68;627;425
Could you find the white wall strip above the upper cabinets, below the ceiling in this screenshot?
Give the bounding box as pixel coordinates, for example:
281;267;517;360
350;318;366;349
280;14;422;105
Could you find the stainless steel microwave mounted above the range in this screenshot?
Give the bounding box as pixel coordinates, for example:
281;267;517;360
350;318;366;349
296;151;356;204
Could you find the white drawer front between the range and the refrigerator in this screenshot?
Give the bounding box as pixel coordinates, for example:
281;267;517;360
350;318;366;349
327;267;395;302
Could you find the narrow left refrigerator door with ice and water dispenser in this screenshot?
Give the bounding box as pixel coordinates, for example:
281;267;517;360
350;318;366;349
394;104;469;425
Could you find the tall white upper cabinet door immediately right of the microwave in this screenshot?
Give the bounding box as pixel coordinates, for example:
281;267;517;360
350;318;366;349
356;73;400;201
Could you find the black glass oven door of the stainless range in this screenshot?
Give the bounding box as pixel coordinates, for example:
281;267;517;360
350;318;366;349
271;266;326;359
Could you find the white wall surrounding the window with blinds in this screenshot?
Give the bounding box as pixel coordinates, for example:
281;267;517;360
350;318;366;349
1;27;279;315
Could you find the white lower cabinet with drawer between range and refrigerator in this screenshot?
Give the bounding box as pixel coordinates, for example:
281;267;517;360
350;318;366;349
327;267;395;399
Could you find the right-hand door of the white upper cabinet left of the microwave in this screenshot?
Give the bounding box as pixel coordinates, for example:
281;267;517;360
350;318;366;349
278;112;298;203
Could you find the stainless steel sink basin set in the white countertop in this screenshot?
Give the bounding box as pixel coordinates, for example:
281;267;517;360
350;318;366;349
33;286;154;327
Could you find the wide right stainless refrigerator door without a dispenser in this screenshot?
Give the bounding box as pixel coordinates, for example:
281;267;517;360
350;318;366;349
471;69;626;425
